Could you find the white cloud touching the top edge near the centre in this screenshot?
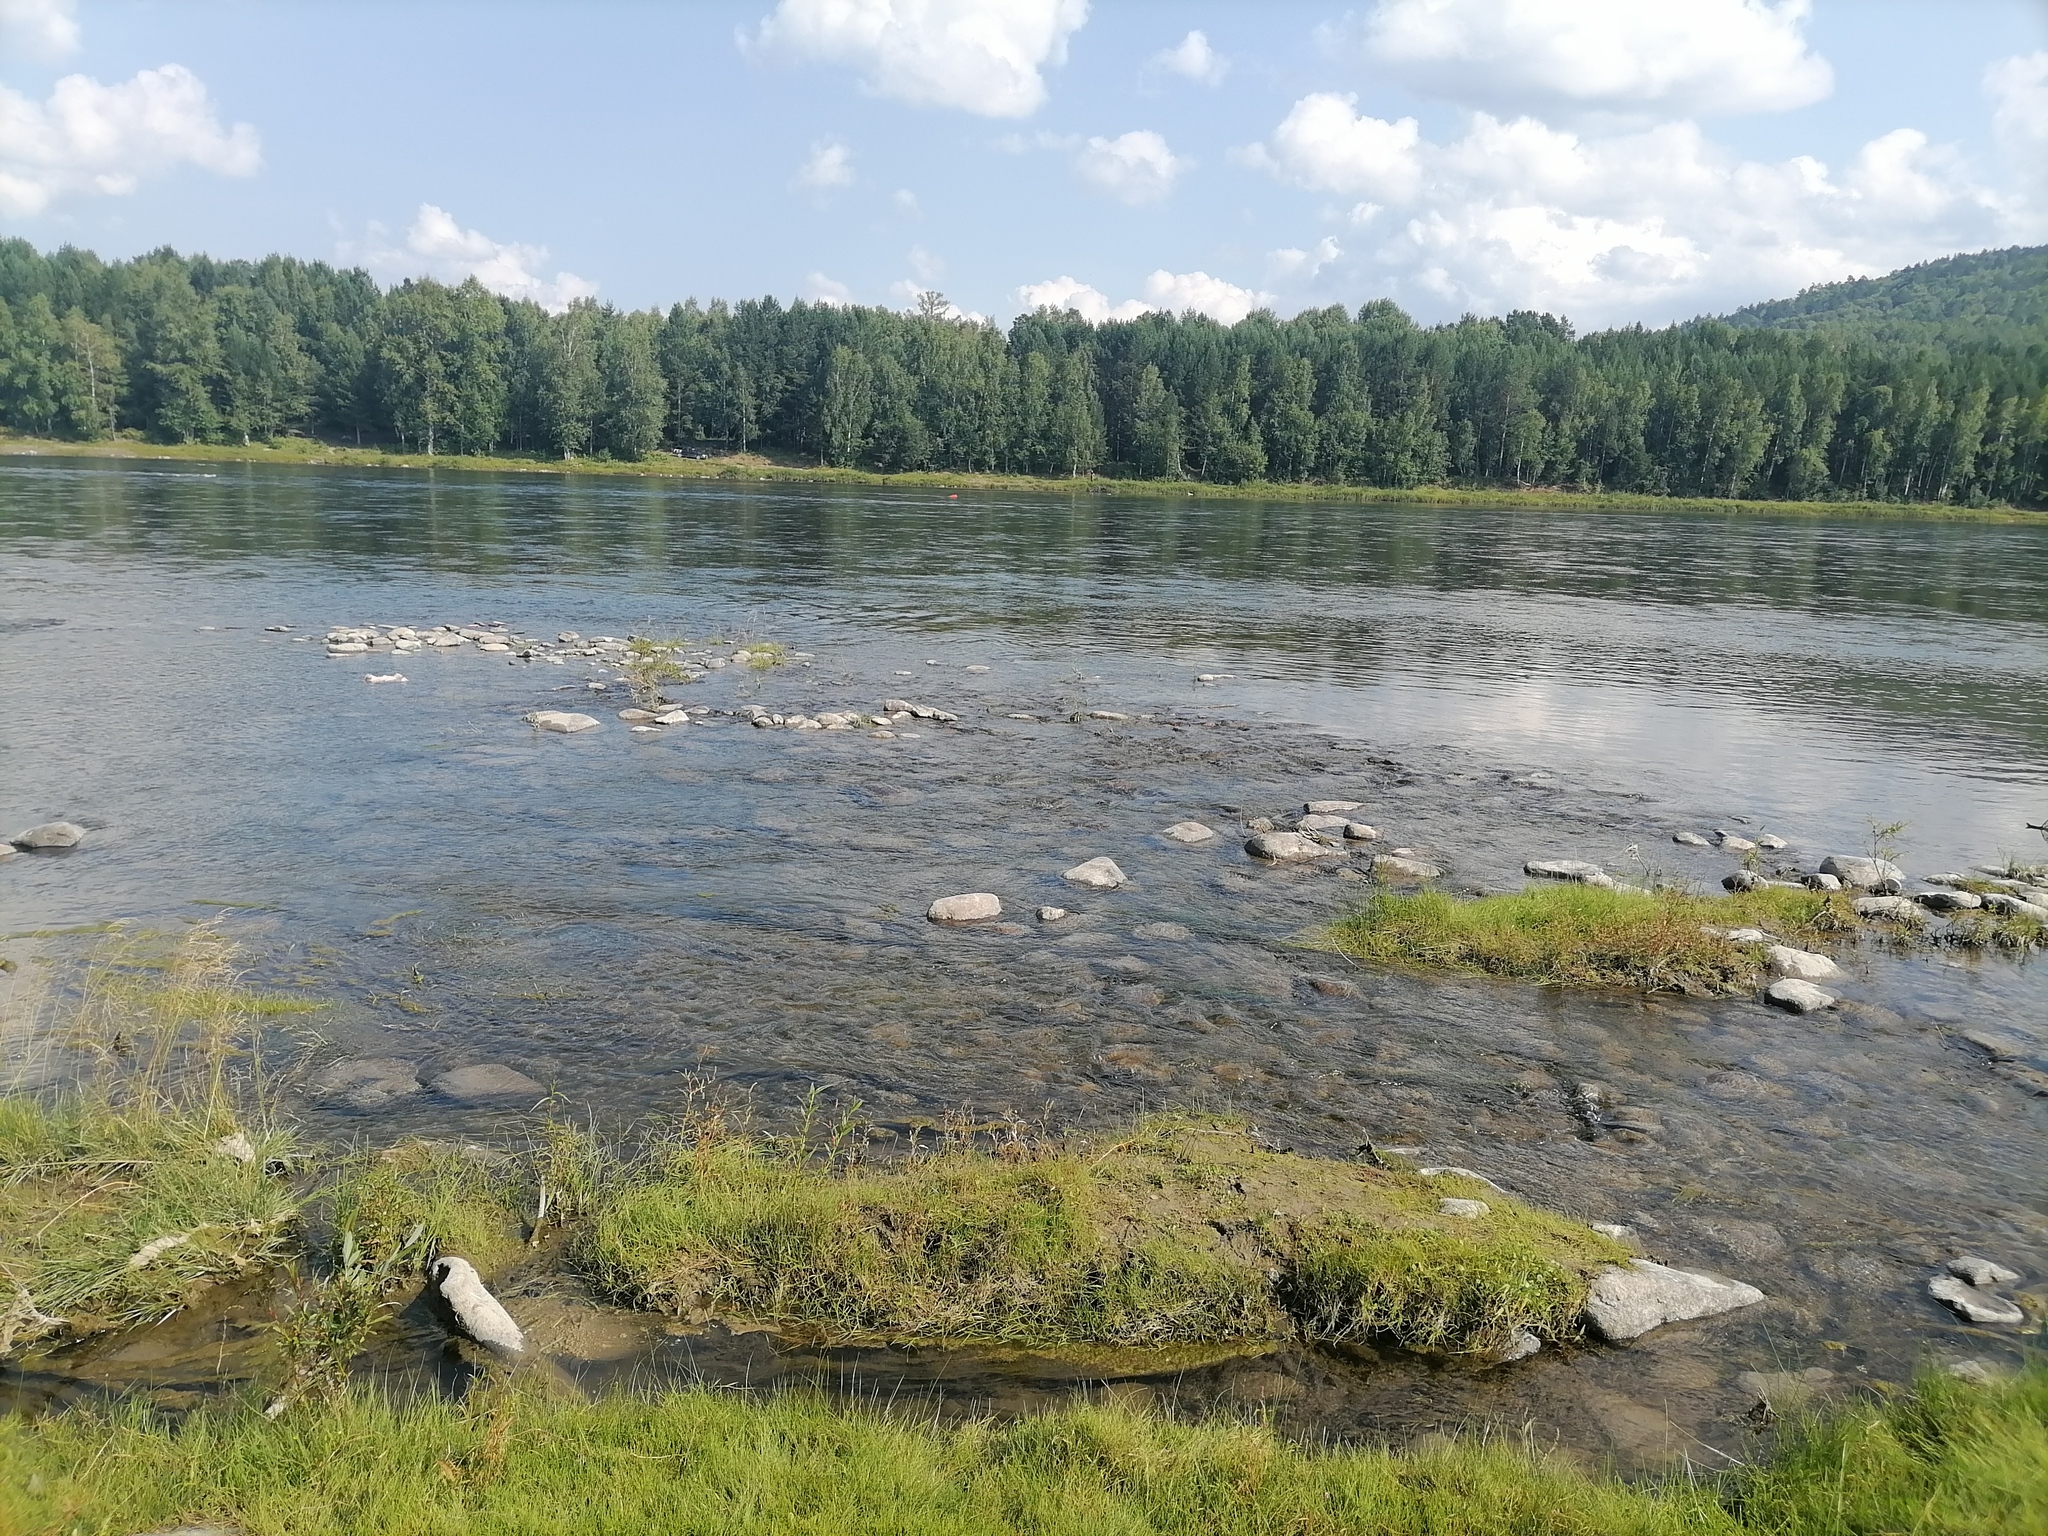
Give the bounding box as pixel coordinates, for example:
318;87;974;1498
741;0;1087;117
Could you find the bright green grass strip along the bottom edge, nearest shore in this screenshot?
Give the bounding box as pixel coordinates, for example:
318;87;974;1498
0;1370;2048;1536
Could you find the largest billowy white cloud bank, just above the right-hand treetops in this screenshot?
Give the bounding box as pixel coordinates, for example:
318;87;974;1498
1239;94;2021;324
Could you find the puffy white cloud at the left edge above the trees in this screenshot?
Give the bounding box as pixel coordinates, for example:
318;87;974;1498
0;63;262;217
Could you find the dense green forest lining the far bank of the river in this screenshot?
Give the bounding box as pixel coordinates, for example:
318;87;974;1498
0;240;2048;506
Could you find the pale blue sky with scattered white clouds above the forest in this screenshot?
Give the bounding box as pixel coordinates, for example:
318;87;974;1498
0;0;2048;330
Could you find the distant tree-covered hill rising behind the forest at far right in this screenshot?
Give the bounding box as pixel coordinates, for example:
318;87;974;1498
1724;246;2048;346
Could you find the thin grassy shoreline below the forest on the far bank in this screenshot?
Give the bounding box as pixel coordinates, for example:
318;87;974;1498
0;434;2048;522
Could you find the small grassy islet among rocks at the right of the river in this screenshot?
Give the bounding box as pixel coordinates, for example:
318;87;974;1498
1327;885;2044;995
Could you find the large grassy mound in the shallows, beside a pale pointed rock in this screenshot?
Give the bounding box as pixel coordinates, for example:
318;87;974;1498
582;1120;1626;1352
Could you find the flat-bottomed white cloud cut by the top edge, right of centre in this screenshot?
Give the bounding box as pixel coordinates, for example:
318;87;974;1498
1325;0;1835;113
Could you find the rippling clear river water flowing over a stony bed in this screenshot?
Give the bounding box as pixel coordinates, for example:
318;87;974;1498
0;457;2048;1464
